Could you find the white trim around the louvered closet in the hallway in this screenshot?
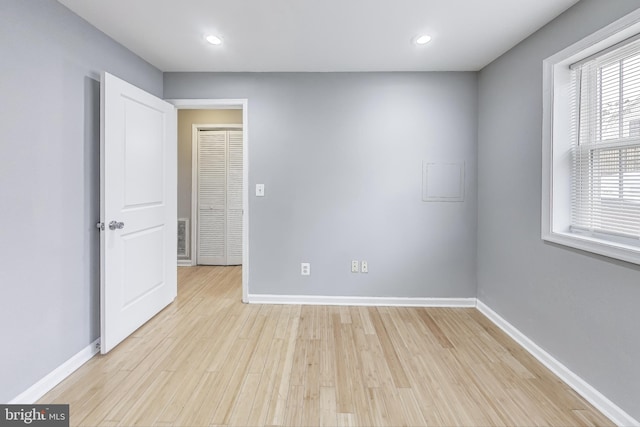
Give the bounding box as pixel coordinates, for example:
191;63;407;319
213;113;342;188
191;123;245;266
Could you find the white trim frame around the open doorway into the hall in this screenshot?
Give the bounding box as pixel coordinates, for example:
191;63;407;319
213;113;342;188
165;98;250;303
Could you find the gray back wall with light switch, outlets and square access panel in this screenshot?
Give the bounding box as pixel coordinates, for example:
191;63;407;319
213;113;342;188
164;73;477;297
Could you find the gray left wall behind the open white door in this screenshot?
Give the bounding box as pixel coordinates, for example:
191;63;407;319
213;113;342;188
0;0;162;403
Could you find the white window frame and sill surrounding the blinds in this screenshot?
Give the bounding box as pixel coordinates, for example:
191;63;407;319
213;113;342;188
542;10;640;264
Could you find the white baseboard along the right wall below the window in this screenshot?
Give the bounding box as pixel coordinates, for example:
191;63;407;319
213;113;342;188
477;300;640;426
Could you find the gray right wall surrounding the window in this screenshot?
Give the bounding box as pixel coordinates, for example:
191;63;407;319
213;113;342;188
478;0;640;419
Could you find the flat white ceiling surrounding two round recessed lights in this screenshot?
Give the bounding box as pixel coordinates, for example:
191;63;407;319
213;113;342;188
58;0;578;71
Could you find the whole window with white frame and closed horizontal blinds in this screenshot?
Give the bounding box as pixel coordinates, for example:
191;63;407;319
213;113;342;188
542;11;640;264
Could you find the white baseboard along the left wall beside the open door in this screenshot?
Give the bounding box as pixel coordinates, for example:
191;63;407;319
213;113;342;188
9;338;100;405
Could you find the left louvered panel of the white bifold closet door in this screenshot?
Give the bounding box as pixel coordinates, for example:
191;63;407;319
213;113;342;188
196;131;227;265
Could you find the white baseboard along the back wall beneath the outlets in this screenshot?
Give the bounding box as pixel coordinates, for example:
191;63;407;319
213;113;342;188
247;294;476;307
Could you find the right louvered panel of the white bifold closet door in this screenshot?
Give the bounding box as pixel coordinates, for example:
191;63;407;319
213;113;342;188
226;130;242;265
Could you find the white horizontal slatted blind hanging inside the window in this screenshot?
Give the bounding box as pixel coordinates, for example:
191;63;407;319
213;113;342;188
571;36;640;240
